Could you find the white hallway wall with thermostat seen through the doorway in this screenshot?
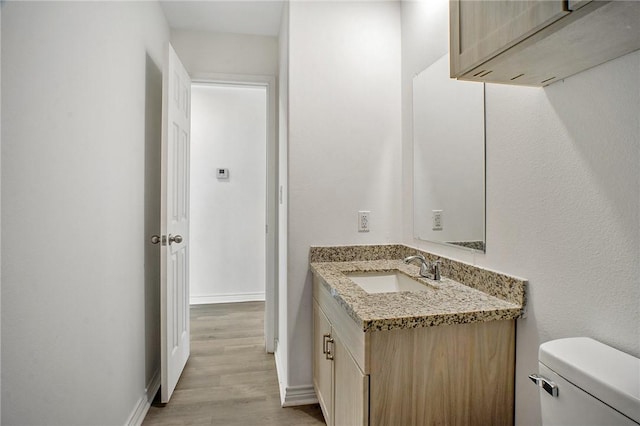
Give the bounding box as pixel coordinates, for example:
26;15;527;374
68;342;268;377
189;84;267;303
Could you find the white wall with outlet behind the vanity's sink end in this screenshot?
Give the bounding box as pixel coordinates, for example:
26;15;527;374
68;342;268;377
280;2;401;400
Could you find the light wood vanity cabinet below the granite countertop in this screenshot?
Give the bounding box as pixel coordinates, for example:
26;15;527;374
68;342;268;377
313;276;515;426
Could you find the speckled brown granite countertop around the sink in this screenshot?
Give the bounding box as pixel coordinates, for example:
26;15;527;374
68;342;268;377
310;260;523;332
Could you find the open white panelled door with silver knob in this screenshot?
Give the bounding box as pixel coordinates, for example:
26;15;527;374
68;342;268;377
160;45;191;403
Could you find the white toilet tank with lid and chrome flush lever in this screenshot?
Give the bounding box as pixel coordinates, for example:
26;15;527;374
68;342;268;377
529;337;640;426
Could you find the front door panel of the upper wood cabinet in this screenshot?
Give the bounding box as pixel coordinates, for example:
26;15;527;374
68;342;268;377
449;0;569;77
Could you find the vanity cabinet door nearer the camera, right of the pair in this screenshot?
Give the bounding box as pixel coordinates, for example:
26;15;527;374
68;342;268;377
333;334;369;426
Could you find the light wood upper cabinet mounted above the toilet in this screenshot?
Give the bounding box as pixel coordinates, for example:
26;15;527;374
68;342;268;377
449;0;640;86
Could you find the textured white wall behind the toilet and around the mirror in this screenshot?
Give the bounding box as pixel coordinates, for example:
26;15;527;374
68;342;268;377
402;0;640;425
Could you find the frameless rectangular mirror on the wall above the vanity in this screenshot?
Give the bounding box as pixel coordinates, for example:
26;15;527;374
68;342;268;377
413;54;486;252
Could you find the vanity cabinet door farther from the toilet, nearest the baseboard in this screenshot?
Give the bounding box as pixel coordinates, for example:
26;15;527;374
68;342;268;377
313;300;334;426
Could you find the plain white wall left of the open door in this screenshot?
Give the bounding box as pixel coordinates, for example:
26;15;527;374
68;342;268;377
2;2;169;425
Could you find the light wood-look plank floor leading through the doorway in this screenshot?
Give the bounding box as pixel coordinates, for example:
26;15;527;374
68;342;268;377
143;302;325;426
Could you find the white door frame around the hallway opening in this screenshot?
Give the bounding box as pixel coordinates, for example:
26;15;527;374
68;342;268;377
191;73;278;353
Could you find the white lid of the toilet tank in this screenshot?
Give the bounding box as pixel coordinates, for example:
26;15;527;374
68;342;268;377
538;337;640;423
